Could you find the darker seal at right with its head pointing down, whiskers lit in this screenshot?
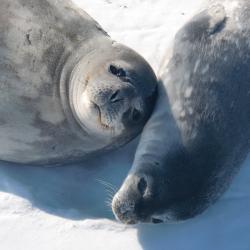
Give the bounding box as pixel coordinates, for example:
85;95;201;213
112;1;250;224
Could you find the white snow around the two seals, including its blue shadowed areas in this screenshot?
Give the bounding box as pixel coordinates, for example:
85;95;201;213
0;0;250;250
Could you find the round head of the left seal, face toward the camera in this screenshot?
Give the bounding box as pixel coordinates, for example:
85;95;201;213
69;41;157;146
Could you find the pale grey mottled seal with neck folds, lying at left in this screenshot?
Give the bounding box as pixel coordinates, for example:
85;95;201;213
0;0;157;164
